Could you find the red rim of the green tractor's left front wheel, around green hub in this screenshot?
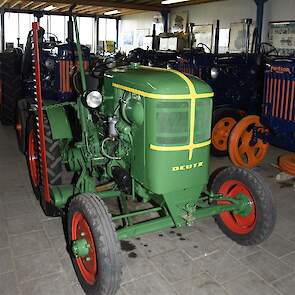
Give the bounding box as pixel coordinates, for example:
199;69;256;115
72;212;97;285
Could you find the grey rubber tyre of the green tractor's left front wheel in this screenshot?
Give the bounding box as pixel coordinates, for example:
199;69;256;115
67;193;122;295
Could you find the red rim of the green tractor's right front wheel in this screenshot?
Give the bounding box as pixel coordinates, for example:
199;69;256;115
218;180;256;235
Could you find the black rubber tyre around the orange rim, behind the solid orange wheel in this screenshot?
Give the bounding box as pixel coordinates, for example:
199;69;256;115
211;108;243;157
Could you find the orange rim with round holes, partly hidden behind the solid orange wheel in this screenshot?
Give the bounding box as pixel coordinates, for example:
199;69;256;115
212;117;237;152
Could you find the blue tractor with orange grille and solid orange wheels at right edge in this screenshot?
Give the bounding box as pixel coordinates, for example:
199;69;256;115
229;57;295;170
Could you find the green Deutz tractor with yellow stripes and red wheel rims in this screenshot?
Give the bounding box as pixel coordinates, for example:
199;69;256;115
27;23;276;295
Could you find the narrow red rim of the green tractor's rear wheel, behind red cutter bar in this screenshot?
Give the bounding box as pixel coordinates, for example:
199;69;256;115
28;129;40;187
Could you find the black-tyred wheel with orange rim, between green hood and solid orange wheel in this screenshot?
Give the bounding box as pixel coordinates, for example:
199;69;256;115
211;108;242;157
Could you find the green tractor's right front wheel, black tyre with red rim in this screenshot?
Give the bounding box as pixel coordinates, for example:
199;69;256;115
211;167;276;246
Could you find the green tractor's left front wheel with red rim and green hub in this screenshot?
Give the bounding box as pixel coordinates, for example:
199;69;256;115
68;193;122;295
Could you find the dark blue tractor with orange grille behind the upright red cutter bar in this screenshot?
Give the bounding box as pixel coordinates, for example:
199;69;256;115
15;16;91;152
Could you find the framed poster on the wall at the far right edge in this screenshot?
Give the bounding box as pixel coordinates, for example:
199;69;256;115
268;21;295;56
